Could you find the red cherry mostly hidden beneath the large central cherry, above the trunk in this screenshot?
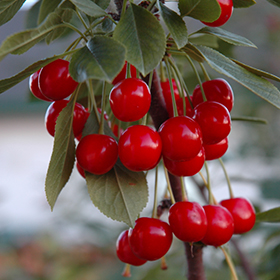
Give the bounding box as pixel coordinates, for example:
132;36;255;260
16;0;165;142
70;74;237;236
163;147;205;177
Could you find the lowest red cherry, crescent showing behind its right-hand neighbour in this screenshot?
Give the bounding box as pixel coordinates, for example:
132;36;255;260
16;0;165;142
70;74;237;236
116;230;147;266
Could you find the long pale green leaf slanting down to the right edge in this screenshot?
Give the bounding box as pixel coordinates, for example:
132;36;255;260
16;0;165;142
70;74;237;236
196;46;280;108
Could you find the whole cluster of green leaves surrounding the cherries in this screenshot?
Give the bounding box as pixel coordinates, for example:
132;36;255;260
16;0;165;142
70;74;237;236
0;0;280;230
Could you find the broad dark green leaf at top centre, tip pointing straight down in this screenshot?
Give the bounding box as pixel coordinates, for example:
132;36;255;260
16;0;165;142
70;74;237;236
113;4;166;76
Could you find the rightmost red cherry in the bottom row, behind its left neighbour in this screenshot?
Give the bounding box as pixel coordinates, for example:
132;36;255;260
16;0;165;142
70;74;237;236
220;197;256;234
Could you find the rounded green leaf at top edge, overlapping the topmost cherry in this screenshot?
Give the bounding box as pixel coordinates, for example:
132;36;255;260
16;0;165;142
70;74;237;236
179;0;221;22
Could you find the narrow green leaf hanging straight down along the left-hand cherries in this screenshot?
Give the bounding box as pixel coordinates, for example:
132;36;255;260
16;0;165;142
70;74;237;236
45;95;76;210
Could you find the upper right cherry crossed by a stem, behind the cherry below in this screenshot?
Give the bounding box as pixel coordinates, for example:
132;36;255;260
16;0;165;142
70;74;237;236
192;78;234;112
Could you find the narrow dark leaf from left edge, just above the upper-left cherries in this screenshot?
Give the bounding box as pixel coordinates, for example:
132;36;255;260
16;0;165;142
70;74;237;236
0;52;78;93
